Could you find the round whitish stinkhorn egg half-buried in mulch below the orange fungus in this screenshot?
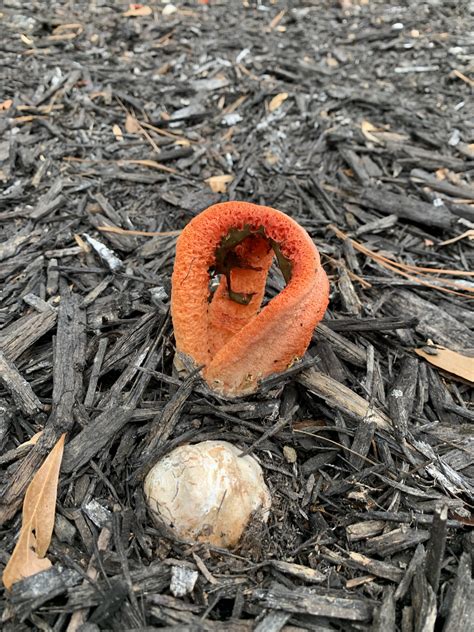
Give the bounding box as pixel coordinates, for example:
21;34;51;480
144;441;271;548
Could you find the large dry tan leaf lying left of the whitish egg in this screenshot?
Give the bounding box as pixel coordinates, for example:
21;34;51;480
2;434;66;590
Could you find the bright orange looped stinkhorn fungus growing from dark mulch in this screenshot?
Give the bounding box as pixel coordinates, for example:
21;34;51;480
171;202;329;396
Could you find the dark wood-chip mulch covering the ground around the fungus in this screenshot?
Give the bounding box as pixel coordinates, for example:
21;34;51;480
0;0;474;632
